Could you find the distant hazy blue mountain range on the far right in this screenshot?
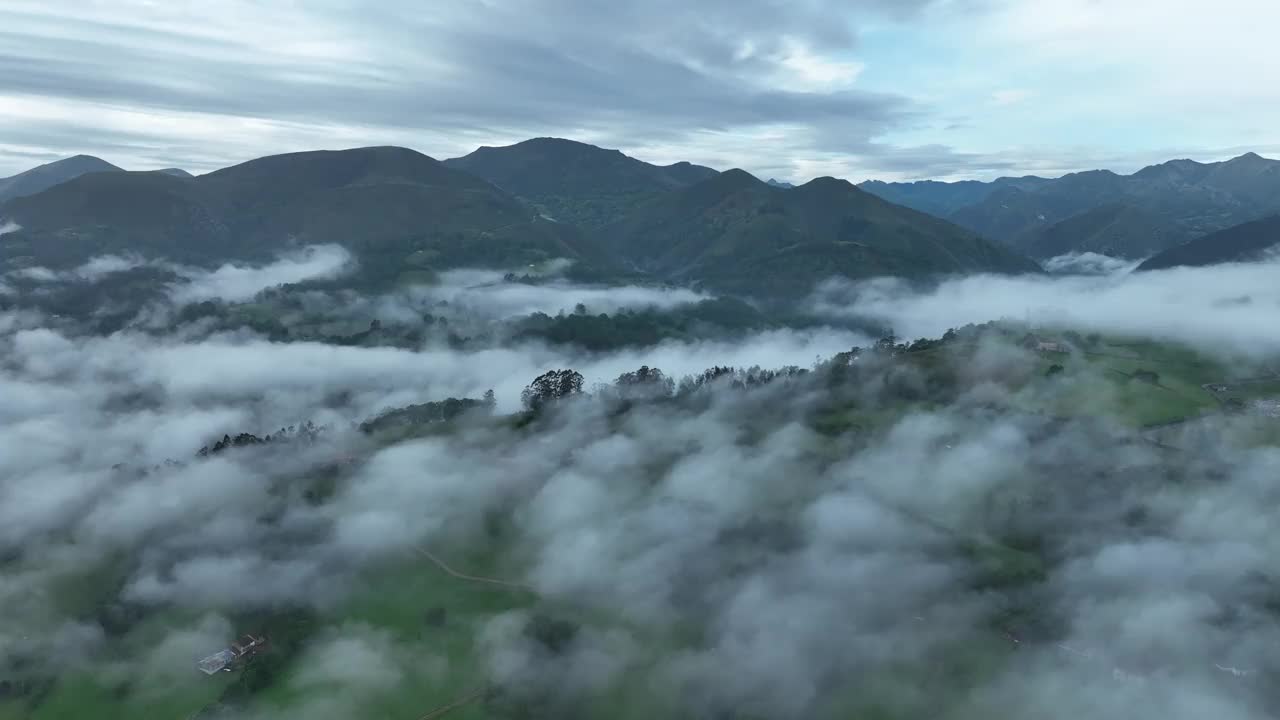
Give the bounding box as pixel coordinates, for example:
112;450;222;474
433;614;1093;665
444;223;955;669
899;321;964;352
861;152;1280;258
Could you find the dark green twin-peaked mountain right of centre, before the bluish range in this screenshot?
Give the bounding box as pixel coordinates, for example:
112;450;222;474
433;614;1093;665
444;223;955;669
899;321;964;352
599;169;1039;297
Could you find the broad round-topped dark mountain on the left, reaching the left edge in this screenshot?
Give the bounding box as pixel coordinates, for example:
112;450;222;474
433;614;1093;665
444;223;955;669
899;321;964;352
0;147;607;283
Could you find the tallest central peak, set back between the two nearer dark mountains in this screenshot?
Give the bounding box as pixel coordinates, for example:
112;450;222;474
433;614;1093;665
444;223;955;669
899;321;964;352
444;137;717;228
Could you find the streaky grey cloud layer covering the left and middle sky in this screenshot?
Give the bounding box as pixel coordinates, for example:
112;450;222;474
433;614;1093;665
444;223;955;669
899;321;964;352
0;0;988;178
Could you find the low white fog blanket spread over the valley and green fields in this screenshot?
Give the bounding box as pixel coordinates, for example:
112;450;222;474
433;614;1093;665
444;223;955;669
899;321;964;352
0;265;1280;719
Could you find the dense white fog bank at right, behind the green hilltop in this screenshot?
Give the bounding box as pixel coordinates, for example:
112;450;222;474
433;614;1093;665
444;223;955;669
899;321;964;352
814;261;1280;355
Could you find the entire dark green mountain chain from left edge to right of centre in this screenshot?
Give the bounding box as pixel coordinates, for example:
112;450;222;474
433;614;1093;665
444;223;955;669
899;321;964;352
0;138;1038;311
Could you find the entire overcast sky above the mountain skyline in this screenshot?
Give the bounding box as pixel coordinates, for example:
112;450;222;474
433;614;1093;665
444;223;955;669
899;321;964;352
0;0;1280;181
